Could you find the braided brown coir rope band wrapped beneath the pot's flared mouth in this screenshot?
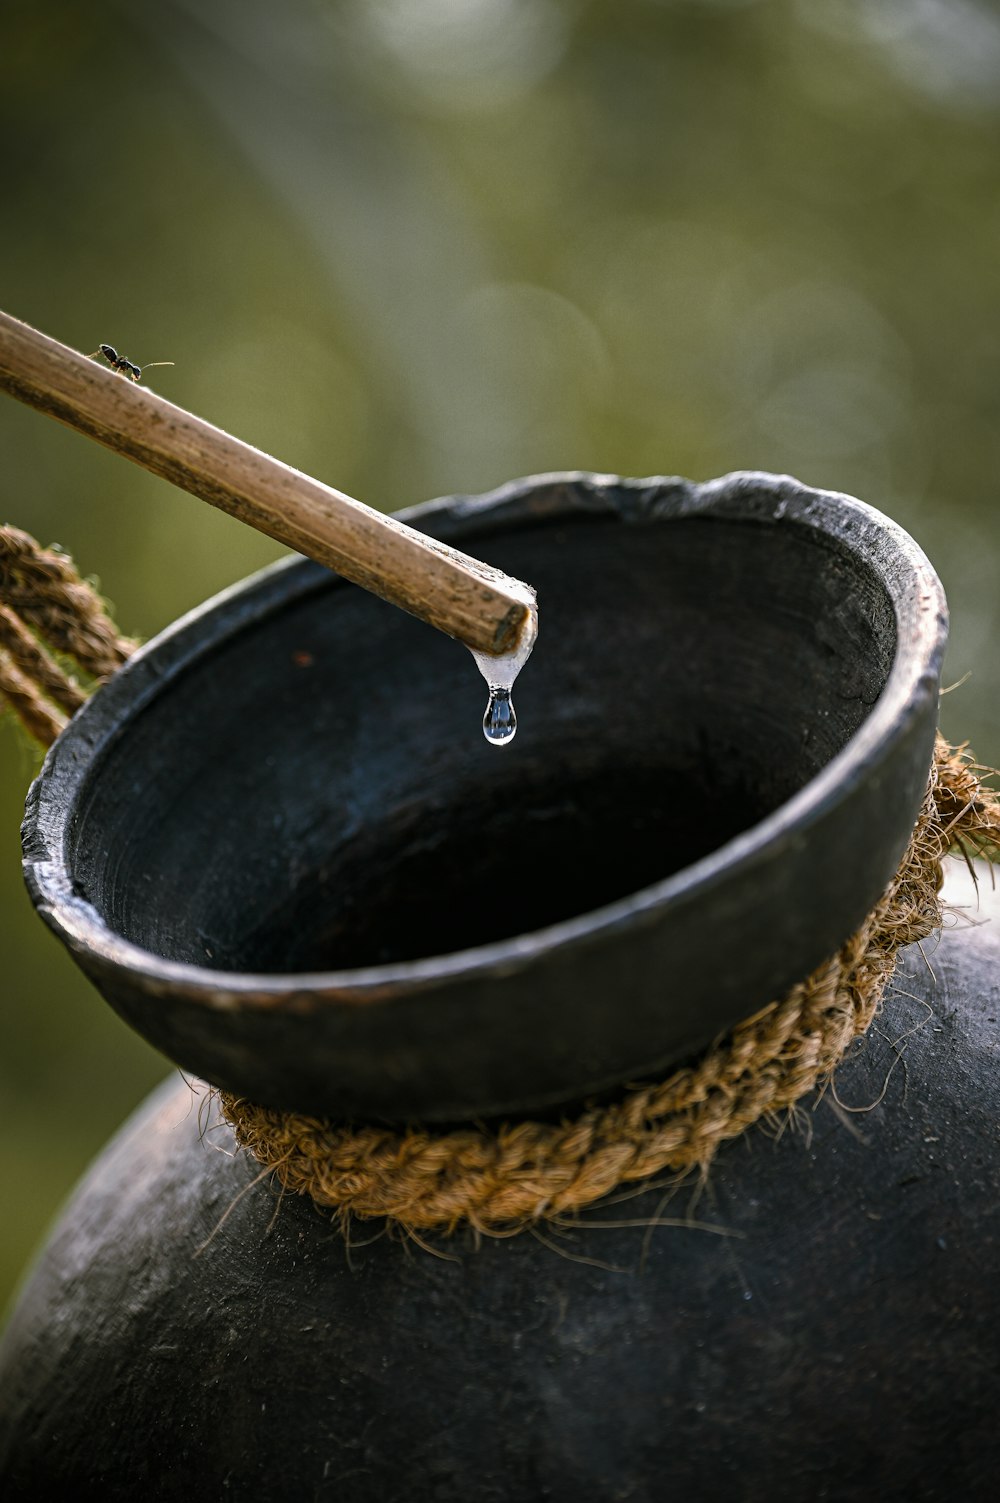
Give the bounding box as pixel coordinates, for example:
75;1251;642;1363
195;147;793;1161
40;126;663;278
221;751;1000;1232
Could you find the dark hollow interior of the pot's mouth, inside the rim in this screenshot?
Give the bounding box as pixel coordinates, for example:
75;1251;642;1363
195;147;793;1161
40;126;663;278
68;514;896;974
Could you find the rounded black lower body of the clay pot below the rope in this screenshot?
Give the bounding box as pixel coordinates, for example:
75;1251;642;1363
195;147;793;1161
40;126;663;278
0;869;1000;1503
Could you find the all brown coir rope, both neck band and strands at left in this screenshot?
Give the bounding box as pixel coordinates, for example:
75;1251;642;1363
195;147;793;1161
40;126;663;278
0;528;1000;1232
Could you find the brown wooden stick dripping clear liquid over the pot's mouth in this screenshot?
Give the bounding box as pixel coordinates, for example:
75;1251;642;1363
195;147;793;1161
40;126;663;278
0;313;534;654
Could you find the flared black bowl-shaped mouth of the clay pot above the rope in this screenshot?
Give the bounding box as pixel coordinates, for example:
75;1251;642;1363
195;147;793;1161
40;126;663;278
24;473;946;1121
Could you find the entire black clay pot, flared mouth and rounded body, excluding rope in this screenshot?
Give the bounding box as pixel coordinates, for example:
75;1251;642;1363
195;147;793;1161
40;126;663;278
0;475;1000;1500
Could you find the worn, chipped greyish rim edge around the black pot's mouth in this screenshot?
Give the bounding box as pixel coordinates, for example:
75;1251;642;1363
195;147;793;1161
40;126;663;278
23;470;947;1009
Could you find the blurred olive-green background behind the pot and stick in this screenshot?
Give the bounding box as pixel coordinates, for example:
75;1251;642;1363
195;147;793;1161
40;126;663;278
0;0;1000;1316
